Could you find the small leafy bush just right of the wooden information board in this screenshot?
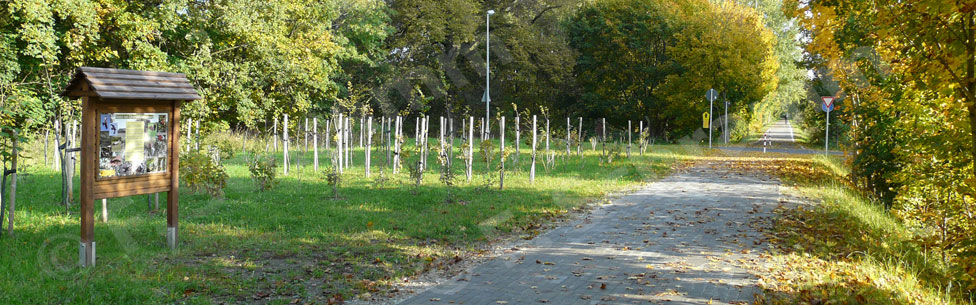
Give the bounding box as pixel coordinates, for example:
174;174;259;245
180;151;227;197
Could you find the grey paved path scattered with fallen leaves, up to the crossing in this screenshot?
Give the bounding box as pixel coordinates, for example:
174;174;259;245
400;162;779;304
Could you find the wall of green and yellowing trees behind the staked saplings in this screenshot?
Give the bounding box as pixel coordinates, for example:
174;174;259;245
0;0;803;140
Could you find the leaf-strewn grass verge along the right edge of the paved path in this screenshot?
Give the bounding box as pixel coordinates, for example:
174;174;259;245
757;156;972;304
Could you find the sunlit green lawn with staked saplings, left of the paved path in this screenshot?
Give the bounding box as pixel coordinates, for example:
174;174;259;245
0;141;700;304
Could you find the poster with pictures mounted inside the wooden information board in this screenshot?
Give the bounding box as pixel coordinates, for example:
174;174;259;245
98;113;169;178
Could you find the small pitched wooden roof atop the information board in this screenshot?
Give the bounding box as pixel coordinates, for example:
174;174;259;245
61;67;201;101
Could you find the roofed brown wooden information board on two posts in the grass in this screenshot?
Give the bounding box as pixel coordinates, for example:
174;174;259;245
61;67;201;266
